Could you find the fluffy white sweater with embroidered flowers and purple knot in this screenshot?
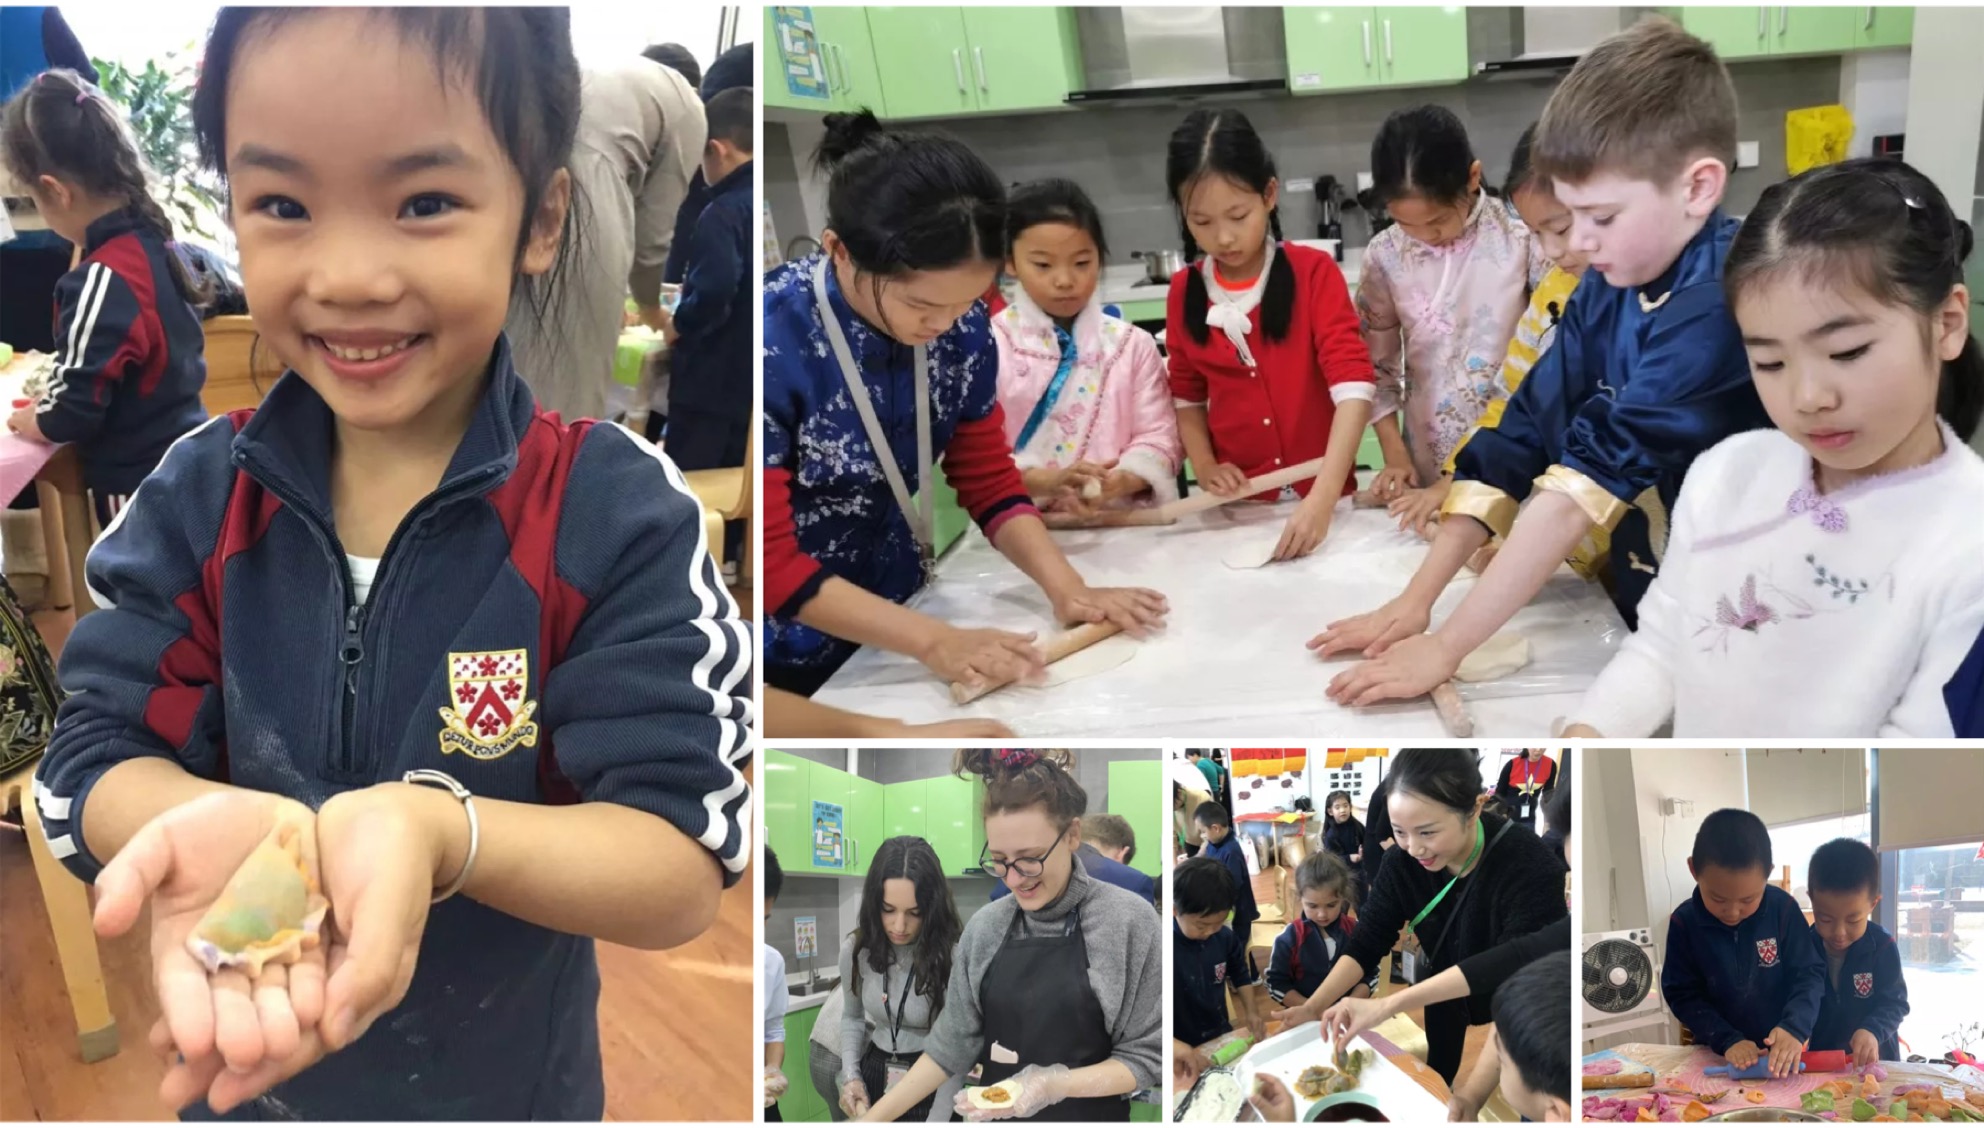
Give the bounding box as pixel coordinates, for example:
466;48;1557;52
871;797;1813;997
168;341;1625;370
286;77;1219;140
1575;426;1984;737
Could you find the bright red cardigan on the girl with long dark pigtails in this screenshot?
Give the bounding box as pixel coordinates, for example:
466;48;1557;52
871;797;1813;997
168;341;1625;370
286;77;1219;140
1165;244;1377;500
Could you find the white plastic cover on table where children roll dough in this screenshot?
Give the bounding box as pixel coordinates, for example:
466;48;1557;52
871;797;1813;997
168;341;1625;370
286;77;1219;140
815;498;1625;739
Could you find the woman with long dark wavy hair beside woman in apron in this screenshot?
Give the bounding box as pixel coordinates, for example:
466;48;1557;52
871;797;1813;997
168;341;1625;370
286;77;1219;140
837;835;964;1120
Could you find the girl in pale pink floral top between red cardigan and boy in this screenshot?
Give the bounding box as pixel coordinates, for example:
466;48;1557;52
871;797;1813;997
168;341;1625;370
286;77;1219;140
1357;105;1550;502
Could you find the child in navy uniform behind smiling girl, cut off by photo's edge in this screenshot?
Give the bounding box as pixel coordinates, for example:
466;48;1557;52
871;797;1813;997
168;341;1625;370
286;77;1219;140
665;87;758;581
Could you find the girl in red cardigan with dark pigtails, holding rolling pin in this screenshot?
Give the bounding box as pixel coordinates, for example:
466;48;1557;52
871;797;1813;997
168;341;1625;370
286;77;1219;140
1165;109;1377;561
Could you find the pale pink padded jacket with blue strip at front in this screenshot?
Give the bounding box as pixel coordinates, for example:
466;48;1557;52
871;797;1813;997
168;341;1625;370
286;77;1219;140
992;289;1184;506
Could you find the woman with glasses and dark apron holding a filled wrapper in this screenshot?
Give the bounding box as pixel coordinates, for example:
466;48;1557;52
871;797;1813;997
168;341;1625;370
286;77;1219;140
863;747;1165;1120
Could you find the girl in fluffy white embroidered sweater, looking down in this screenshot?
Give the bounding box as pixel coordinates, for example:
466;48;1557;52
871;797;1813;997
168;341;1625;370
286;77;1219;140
1563;161;1984;737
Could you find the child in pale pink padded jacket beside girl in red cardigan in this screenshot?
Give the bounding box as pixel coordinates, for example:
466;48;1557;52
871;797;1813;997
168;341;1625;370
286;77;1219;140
992;180;1182;511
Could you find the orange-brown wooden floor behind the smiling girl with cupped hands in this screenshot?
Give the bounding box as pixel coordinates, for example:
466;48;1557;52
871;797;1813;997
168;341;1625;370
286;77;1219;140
0;589;758;1122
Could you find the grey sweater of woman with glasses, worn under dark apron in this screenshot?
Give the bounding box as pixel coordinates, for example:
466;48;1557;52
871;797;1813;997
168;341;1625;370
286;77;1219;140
923;858;1165;1088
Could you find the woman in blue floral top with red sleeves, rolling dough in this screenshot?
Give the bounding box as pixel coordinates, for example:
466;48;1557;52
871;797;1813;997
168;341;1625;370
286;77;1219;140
764;113;1165;696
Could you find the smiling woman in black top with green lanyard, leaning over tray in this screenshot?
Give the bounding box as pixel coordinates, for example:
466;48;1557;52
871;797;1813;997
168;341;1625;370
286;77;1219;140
1284;747;1569;1084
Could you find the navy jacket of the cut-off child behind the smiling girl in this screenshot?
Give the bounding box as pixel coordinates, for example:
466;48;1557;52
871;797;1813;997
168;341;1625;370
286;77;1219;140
667;161;758;470
